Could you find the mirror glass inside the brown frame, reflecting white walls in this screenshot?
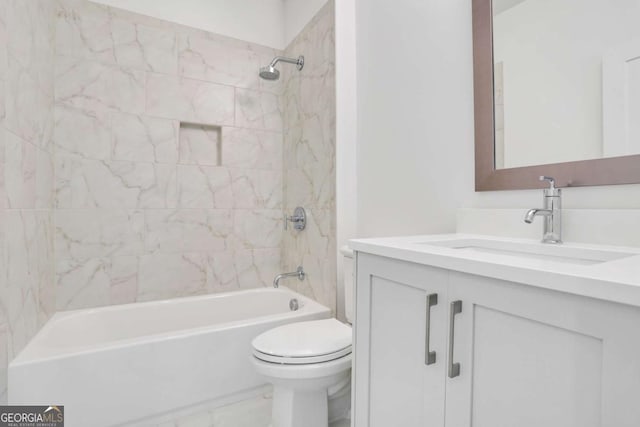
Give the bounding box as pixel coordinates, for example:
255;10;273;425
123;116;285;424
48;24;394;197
493;0;640;169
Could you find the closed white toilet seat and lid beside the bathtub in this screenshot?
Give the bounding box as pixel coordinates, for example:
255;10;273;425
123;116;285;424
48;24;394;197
253;319;351;363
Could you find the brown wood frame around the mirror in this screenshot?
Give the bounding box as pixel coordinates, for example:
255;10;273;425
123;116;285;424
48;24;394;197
472;0;640;191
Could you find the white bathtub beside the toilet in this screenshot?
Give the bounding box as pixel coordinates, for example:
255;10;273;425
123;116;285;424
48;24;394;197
8;287;331;427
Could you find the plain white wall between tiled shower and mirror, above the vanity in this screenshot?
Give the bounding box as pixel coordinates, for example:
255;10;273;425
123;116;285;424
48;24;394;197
356;0;640;241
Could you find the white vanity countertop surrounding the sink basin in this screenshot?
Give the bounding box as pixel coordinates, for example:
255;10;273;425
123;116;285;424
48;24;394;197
349;234;640;307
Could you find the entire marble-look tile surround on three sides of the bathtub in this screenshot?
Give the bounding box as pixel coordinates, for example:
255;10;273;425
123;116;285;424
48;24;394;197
0;0;336;402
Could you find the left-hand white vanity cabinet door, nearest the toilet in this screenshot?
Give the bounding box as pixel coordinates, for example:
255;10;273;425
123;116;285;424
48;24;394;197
354;254;448;427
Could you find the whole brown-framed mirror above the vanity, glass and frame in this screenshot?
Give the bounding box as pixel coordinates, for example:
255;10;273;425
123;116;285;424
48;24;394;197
472;0;640;191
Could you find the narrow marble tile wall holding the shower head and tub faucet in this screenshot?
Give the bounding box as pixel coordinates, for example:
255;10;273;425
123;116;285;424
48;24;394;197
283;0;336;312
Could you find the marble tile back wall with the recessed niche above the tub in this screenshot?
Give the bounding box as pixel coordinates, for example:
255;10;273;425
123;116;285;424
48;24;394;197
53;0;283;310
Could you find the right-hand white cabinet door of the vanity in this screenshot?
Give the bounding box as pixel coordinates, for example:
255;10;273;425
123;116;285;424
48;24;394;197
446;272;640;427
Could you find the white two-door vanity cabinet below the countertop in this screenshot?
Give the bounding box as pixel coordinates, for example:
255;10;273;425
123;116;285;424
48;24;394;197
353;252;640;427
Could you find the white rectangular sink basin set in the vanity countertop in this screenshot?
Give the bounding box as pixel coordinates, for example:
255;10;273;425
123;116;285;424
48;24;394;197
419;239;637;265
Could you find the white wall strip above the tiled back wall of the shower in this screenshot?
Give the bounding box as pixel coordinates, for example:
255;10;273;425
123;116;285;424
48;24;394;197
92;0;286;49
